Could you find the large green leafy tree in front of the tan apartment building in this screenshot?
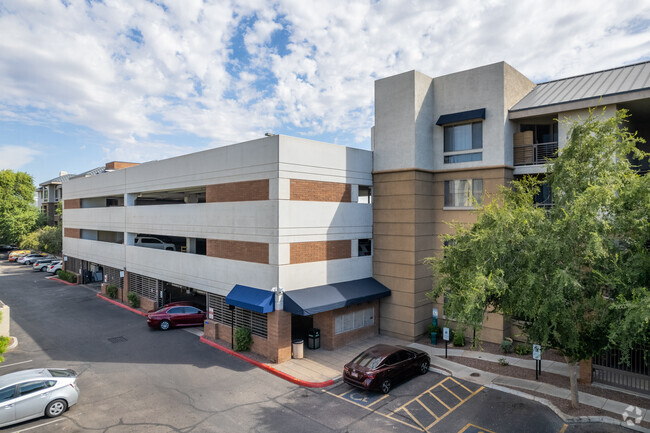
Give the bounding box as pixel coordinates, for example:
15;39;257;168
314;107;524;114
427;111;650;407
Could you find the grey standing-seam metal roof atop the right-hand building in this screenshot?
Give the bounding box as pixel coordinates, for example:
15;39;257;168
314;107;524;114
510;61;650;111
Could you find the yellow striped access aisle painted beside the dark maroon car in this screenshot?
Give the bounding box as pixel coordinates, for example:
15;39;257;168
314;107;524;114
385;377;483;433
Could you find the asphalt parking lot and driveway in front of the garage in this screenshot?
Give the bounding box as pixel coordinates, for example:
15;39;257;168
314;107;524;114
0;259;624;433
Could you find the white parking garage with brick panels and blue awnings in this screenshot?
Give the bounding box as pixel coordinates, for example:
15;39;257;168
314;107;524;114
63;135;380;362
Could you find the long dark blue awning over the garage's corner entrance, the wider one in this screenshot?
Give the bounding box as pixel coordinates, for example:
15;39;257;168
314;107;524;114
284;278;390;316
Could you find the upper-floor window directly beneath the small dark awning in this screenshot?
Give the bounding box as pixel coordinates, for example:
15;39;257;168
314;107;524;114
444;122;483;164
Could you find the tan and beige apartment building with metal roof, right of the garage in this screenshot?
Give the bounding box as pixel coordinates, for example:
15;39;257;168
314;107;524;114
372;62;650;343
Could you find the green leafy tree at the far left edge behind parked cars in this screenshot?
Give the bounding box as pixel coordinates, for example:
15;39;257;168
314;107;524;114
0;170;42;244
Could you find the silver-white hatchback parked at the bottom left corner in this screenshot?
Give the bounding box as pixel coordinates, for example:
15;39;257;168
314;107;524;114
0;368;79;427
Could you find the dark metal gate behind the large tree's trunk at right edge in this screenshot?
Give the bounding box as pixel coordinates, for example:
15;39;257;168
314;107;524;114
592;347;650;395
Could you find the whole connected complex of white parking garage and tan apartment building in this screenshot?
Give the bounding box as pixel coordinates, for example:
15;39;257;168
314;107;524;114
63;62;650;362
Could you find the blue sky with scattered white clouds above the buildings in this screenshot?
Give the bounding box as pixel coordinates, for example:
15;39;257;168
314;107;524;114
0;0;650;184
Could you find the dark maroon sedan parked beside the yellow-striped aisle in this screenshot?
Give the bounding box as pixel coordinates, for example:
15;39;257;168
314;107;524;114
343;344;431;394
